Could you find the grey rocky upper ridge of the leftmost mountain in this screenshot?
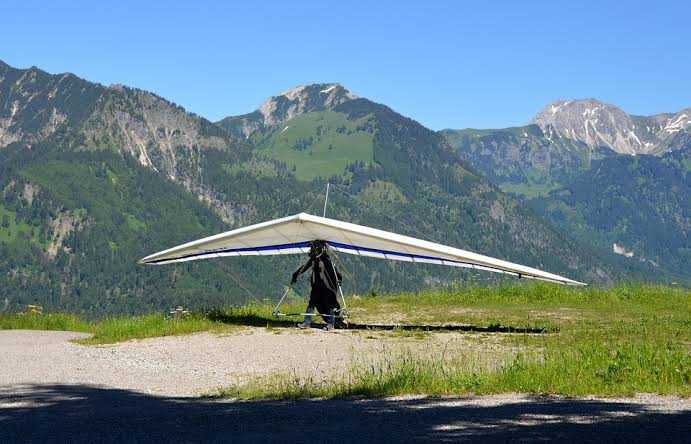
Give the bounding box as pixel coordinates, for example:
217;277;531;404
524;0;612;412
0;64;242;179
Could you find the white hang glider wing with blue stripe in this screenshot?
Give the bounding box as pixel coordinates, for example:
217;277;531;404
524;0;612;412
139;213;585;285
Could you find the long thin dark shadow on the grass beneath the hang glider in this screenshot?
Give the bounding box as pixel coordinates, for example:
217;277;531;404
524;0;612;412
207;312;558;333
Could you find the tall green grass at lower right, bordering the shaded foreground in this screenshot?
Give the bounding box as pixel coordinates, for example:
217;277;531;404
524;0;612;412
216;330;691;399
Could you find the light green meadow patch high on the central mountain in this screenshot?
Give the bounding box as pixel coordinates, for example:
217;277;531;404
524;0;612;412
257;111;374;180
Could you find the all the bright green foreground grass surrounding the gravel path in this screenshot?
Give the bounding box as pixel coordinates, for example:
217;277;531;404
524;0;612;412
0;284;691;398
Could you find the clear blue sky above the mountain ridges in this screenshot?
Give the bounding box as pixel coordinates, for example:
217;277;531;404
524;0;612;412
0;0;691;129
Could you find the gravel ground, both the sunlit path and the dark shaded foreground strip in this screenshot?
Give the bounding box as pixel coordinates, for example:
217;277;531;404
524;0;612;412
0;328;691;443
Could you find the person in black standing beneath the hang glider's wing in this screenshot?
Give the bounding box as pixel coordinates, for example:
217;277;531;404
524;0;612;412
290;241;343;331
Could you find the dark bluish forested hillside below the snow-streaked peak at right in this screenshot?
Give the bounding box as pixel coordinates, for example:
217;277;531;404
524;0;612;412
531;147;691;280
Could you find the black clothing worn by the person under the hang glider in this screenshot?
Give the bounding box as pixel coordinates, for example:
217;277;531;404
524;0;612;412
293;253;342;323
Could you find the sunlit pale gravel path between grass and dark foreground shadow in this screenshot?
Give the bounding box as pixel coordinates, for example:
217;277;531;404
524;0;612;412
0;328;512;396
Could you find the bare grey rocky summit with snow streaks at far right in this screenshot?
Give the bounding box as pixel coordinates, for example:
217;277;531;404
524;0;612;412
533;99;691;155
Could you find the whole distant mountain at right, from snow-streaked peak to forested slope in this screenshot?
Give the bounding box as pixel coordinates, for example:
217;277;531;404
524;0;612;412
442;99;691;280
